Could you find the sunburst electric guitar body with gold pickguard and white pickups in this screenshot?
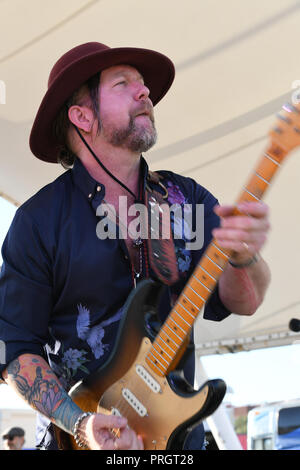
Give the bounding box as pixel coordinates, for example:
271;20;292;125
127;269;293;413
56;280;226;450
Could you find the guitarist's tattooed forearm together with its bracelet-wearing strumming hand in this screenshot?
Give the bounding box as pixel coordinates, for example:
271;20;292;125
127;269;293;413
3;354;143;450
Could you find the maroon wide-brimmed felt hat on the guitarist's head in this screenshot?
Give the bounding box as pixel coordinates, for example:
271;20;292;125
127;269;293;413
29;42;175;163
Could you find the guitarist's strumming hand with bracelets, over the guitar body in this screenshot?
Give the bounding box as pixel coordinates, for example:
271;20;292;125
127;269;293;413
80;413;144;450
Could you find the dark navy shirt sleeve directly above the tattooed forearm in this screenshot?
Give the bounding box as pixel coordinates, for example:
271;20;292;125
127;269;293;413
0;208;52;373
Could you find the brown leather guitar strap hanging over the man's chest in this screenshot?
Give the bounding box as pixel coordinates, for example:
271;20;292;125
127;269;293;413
145;171;179;285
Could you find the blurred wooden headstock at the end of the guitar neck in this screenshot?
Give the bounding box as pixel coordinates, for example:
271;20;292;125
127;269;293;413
269;103;300;153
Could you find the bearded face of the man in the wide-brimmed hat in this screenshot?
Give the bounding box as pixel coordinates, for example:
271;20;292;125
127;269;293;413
99;65;157;153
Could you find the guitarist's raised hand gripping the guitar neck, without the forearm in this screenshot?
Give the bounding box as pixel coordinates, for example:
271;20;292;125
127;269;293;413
212;202;270;263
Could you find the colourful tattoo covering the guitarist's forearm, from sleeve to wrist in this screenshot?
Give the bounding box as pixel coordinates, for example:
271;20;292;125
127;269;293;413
6;354;82;434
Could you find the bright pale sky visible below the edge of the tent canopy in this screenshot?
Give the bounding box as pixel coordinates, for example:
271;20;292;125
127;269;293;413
0;197;300;408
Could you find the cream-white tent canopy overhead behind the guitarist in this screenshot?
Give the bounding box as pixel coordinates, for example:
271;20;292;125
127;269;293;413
0;0;300;354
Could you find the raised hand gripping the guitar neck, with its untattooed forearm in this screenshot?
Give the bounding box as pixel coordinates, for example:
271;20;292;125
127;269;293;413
212;202;271;315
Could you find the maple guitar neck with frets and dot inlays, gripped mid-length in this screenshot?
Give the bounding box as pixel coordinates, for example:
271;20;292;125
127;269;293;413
146;139;288;376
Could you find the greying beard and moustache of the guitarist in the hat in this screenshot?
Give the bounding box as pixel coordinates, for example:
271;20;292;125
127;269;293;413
101;109;157;153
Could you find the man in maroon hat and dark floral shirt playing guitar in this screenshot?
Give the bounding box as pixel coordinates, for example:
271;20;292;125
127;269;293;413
0;43;269;450
